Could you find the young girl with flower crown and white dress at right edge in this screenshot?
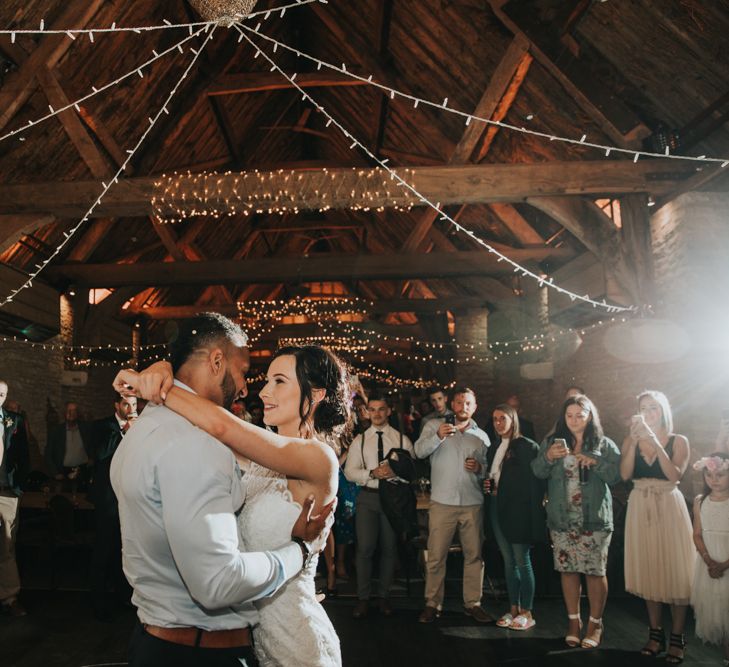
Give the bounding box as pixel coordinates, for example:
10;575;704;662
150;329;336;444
691;452;729;666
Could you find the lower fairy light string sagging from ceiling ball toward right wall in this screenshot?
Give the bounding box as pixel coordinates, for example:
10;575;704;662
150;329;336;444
236;24;637;313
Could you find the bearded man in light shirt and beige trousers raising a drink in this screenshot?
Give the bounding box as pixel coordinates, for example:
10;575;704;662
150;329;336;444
415;387;494;623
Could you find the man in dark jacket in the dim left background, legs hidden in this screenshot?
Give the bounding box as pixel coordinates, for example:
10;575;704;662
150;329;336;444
45;402;94;490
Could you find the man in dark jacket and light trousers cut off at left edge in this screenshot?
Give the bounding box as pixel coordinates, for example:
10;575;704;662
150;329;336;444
0;380;29;616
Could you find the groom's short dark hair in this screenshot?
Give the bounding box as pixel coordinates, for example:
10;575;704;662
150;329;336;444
170;313;248;373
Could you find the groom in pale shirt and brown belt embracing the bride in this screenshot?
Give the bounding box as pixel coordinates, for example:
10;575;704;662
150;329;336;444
111;313;326;667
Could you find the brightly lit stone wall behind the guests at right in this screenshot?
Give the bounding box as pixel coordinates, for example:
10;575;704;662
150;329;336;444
482;193;729;494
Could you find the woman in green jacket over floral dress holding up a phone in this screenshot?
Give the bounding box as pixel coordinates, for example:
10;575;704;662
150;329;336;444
532;395;620;648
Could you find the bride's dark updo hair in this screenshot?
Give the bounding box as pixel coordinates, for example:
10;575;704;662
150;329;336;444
273;345;352;437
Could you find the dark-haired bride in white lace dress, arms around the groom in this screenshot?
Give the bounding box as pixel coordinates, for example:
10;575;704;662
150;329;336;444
114;345;350;667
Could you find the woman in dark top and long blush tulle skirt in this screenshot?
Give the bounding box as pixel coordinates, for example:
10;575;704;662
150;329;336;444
620;391;696;665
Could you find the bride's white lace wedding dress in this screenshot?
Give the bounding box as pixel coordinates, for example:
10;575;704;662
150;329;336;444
238;463;342;667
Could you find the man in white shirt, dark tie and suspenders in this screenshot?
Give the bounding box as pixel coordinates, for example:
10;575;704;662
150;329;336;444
344;396;413;618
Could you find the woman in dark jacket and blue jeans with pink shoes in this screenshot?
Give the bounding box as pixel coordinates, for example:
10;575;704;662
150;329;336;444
484;403;546;630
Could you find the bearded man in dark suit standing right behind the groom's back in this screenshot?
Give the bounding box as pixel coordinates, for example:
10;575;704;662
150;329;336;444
88;396;137;620
